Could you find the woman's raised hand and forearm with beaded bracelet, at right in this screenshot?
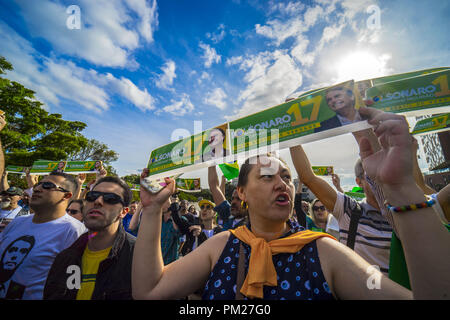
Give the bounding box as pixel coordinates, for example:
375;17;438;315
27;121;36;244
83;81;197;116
360;107;450;299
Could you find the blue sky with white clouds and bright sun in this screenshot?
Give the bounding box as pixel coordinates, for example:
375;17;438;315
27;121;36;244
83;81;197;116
0;0;450;190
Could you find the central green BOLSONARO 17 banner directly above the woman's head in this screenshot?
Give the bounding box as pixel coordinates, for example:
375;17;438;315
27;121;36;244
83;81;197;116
229;80;369;155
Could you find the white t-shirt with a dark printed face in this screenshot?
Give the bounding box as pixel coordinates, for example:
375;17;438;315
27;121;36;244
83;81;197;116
0;214;87;300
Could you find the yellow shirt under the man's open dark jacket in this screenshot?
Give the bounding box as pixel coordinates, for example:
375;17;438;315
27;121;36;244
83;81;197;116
77;246;111;300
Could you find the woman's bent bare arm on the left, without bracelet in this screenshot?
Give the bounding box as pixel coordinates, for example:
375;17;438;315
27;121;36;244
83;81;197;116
132;169;229;299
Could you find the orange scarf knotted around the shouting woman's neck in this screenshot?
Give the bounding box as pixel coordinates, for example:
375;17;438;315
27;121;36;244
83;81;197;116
229;226;336;299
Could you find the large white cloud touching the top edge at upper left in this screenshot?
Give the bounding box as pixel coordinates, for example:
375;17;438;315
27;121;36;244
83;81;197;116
15;0;157;68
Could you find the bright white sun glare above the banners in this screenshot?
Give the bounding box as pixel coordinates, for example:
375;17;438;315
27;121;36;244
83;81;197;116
336;51;390;82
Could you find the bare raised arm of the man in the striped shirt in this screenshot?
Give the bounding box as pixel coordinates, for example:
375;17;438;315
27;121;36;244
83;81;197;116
290;145;337;212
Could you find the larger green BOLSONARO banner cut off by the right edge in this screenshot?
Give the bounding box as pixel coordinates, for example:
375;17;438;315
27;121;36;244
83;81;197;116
366;69;450;116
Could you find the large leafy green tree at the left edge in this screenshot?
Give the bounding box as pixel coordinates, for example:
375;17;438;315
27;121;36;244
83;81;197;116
0;56;88;166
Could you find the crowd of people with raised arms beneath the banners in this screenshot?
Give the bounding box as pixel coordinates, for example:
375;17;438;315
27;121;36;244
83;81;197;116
0;107;450;300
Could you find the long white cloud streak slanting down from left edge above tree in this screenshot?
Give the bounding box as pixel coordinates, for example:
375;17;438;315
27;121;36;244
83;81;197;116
0;23;154;112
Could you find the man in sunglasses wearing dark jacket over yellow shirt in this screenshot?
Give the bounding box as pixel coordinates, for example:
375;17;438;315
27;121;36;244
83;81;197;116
44;177;136;300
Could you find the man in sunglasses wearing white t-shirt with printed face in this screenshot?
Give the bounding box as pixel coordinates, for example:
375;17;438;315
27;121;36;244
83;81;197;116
0;172;86;300
